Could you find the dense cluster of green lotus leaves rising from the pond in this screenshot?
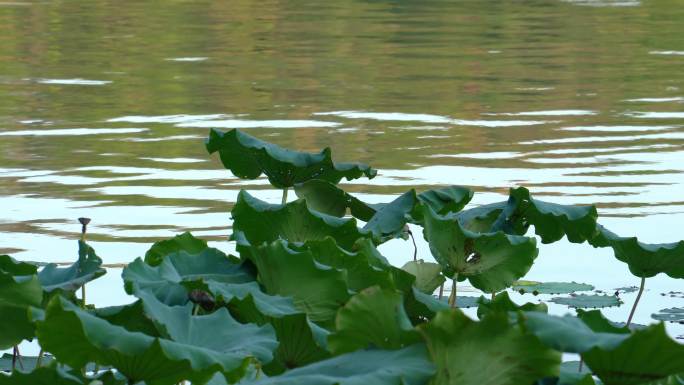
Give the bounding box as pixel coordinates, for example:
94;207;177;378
0;130;684;385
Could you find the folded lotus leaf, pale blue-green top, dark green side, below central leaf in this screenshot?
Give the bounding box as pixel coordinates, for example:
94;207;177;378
184;281;330;374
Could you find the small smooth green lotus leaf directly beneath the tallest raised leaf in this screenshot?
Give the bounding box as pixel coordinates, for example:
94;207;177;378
295;179;384;222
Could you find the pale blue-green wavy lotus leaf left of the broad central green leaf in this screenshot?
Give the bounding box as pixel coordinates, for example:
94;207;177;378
121;248;254;305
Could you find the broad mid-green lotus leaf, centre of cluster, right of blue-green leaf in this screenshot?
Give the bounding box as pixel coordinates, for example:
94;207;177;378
248;241;350;324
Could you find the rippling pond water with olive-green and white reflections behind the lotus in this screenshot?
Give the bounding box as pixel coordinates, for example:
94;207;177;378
0;0;684;344
